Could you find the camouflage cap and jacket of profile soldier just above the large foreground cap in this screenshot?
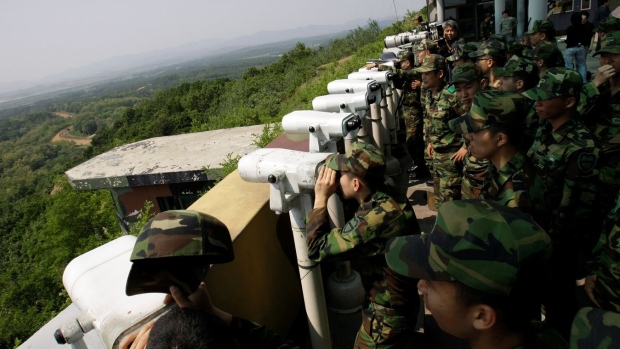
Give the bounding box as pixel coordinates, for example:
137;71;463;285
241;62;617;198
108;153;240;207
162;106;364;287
450;91;535;213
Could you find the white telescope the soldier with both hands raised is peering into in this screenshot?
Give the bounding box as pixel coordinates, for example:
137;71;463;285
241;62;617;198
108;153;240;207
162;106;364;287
239;148;330;213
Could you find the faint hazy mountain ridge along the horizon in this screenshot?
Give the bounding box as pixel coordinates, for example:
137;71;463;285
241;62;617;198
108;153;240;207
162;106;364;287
0;19;393;104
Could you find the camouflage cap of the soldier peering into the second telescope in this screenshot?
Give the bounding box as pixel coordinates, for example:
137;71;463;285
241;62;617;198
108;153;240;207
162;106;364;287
325;142;385;180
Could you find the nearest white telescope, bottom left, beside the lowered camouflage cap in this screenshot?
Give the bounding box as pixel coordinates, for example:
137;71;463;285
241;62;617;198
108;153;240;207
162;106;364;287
55;235;167;348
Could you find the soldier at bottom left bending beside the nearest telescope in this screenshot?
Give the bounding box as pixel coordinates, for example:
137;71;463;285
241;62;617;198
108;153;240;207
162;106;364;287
119;210;299;349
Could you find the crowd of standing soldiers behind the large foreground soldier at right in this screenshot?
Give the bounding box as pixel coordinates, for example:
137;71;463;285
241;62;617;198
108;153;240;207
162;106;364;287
378;16;620;344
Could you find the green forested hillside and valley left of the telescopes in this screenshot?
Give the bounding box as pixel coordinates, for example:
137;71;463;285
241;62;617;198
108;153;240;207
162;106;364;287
0;12;424;348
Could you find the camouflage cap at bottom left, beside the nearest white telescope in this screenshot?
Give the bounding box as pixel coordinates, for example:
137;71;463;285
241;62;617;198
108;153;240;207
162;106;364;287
125;210;234;296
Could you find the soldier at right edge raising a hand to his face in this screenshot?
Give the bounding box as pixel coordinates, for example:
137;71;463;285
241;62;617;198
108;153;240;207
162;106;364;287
579;31;620;213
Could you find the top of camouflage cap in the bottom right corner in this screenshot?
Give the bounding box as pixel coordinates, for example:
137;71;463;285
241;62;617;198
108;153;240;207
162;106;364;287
570;308;620;349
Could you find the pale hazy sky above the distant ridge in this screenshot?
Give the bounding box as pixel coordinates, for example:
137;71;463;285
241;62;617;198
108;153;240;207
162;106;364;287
0;0;426;82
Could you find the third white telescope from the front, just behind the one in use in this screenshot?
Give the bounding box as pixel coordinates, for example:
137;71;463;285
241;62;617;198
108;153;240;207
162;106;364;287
282;110;361;153
